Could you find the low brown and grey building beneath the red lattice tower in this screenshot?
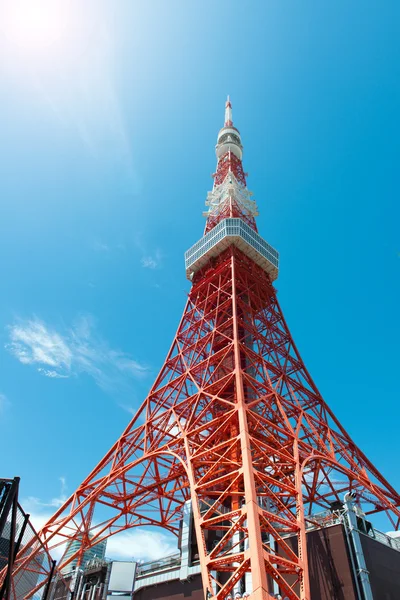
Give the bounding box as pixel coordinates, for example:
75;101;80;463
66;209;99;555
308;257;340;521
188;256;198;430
53;501;400;600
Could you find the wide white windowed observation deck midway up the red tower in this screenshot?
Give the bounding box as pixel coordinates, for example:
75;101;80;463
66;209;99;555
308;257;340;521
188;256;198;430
185;218;279;281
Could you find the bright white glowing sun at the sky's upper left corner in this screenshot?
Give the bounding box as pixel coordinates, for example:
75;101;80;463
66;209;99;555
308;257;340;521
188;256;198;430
0;0;71;51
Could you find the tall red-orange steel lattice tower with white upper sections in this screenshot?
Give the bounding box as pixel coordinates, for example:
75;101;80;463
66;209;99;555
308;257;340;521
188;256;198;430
12;97;400;600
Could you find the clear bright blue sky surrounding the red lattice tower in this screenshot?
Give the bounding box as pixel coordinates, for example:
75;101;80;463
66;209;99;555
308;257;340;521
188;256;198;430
0;0;400;543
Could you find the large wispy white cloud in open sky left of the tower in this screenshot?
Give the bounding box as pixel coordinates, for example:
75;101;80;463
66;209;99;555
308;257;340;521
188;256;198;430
6;316;148;391
